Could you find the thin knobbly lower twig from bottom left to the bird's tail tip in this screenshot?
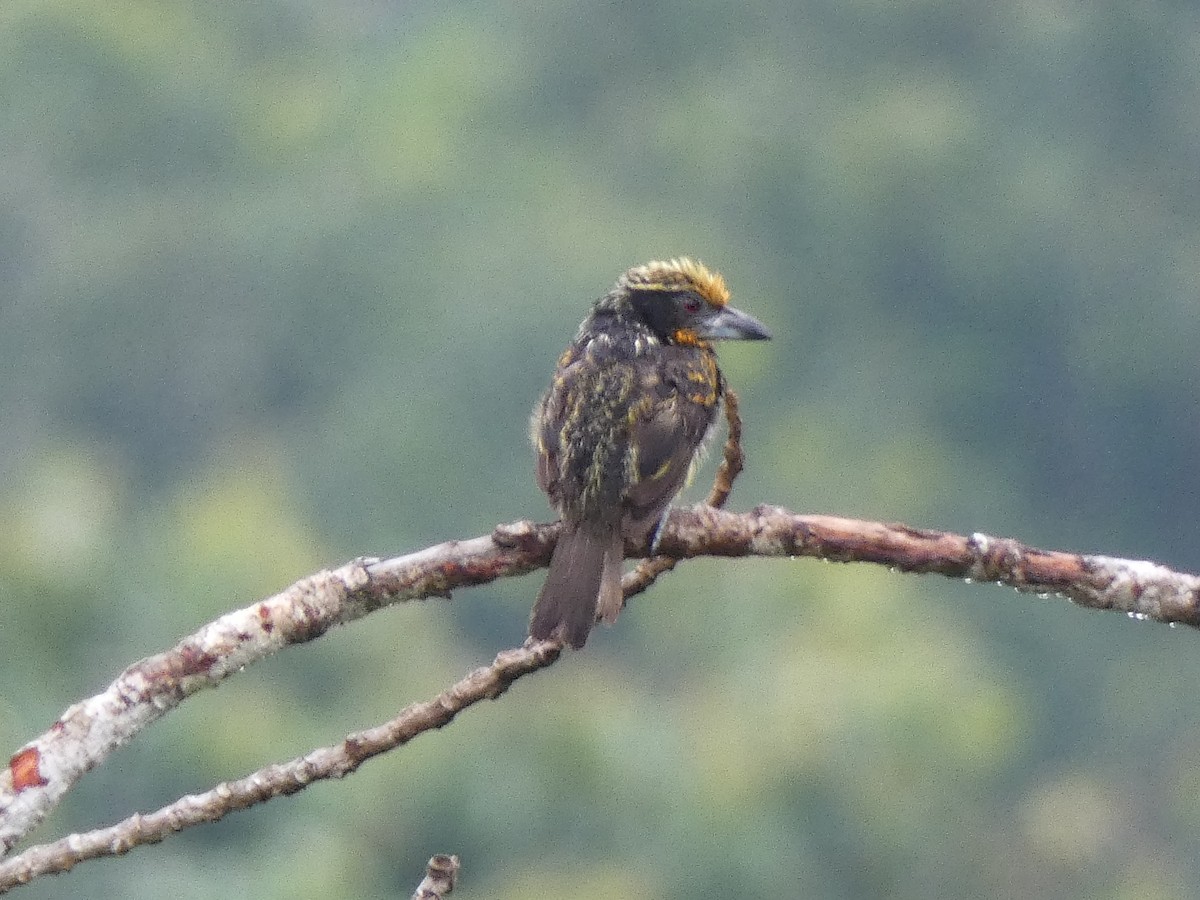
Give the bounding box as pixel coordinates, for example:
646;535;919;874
0;641;562;893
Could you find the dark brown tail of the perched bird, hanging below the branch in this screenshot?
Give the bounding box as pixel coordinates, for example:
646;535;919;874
529;523;624;649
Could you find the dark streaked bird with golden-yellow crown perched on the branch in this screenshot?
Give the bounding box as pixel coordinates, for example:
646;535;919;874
529;257;770;649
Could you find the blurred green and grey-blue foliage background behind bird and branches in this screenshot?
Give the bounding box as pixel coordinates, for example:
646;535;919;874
0;0;1200;900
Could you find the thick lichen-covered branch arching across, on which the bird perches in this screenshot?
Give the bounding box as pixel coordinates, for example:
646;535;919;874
0;505;1200;873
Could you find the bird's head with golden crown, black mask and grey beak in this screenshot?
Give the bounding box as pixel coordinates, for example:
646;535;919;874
601;257;770;344
